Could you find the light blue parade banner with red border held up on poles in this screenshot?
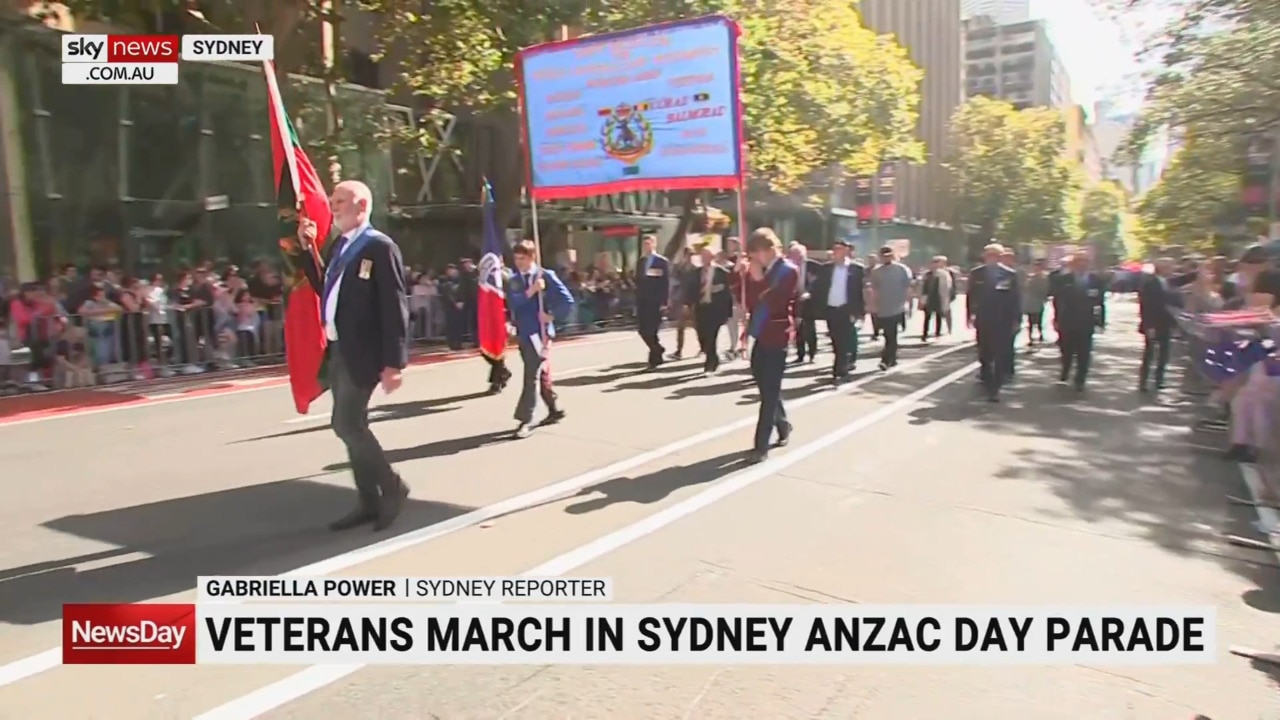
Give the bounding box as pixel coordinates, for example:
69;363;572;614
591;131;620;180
516;15;744;200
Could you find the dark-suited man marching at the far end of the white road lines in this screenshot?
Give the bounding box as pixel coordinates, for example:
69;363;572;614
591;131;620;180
965;243;1023;402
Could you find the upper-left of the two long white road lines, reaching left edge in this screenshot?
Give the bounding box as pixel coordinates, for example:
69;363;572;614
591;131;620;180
0;342;973;687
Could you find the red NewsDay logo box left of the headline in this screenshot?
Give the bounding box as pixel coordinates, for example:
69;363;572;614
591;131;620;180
63;603;196;665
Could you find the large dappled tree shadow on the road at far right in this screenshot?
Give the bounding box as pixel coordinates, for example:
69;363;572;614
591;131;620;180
910;328;1280;635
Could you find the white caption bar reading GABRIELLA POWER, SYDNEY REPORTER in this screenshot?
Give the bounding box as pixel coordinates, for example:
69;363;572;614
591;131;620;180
196;577;613;603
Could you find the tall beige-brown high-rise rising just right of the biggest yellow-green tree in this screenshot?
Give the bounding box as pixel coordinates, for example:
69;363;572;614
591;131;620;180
858;0;965;223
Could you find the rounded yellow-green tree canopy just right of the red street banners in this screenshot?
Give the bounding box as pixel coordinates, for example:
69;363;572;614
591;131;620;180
947;97;1080;255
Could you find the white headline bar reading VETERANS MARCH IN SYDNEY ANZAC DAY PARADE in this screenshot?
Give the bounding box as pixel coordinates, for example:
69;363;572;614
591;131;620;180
196;603;1217;665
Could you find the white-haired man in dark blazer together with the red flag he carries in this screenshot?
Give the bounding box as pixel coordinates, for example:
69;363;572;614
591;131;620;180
262;61;408;532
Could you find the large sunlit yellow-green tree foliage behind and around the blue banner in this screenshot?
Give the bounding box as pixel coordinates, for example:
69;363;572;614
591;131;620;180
361;0;923;252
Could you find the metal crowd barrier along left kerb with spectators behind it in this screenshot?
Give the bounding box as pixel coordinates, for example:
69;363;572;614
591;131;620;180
0;296;635;393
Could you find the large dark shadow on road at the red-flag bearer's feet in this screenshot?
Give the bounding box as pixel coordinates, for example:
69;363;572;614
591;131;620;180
0;475;475;625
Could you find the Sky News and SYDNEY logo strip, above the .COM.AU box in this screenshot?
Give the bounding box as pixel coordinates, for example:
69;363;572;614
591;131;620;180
63;35;275;64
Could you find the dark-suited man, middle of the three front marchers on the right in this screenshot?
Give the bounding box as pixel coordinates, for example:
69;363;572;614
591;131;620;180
1050;255;1105;391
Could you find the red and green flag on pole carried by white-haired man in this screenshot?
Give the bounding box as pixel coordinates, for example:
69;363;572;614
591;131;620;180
262;60;333;415
